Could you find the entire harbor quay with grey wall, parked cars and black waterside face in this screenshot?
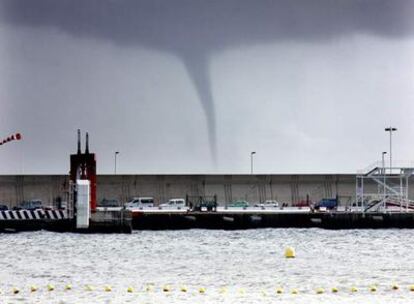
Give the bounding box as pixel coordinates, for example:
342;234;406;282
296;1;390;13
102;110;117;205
0;168;414;232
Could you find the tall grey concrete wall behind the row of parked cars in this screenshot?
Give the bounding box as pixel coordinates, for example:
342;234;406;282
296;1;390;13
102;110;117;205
0;174;414;207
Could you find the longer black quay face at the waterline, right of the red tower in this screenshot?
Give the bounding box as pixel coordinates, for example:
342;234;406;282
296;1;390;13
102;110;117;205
132;211;414;230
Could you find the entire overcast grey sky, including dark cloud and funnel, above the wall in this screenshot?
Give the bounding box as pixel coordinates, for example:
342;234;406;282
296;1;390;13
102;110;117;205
0;0;414;174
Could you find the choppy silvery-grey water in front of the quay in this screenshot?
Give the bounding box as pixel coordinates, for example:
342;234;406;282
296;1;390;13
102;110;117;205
0;229;414;303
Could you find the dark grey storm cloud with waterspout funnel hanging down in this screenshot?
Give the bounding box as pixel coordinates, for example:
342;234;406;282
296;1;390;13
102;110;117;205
0;0;414;162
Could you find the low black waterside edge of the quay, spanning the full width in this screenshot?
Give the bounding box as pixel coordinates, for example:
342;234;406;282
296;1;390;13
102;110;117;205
4;210;414;233
